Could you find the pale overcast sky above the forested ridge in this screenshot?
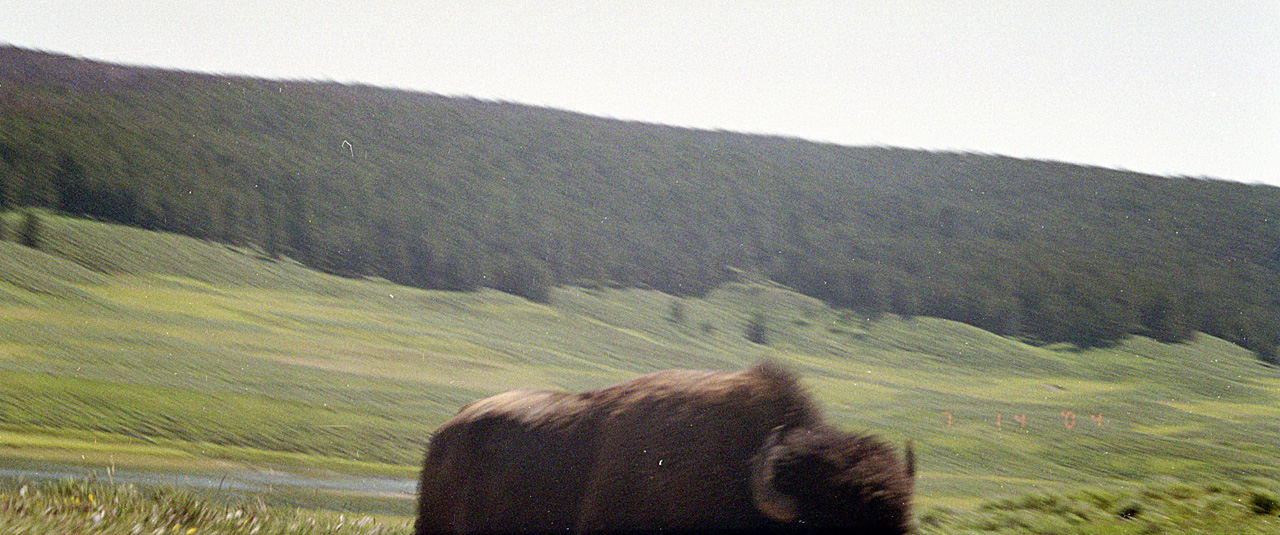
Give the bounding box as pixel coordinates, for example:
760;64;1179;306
0;0;1280;186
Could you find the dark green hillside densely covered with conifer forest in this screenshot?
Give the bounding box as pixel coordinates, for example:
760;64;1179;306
0;47;1280;361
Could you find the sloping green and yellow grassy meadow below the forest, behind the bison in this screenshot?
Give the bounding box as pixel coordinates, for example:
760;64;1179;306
0;214;1280;534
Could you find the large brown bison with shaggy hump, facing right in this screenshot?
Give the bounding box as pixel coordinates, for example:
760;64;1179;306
415;362;915;535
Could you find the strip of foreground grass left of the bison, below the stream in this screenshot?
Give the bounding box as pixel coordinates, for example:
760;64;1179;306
0;480;411;535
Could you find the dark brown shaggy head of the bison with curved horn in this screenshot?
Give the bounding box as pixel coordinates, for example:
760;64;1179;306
751;427;915;534
